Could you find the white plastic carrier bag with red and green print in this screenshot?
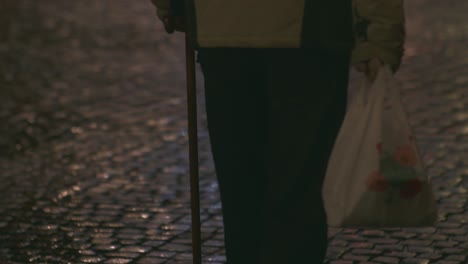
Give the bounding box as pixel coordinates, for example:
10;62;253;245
323;65;437;227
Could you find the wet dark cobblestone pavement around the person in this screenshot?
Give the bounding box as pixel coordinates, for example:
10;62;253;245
0;0;468;264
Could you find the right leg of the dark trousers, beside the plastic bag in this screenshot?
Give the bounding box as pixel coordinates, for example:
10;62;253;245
261;49;349;264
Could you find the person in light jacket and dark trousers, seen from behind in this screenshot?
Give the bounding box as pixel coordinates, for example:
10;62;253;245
151;0;405;264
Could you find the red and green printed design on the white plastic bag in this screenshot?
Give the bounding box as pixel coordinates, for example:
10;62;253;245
366;135;425;202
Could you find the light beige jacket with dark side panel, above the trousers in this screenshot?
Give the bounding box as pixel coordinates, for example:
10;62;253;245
152;0;405;71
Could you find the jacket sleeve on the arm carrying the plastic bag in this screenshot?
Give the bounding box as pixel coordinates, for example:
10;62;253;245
352;0;405;72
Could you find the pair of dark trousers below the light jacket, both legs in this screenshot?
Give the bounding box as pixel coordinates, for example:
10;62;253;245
198;48;350;264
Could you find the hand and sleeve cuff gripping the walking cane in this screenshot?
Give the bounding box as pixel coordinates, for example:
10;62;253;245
151;0;187;34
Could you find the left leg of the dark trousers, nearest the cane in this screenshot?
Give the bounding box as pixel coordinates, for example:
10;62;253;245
199;49;266;264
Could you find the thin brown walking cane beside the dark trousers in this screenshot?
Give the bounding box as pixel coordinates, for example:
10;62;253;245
166;0;202;264
